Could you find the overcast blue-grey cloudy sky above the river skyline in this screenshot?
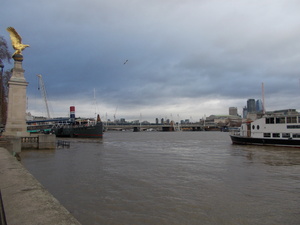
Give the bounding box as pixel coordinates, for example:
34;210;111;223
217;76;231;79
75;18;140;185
0;0;300;122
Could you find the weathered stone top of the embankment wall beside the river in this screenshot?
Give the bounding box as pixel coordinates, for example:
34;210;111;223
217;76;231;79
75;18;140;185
0;147;80;225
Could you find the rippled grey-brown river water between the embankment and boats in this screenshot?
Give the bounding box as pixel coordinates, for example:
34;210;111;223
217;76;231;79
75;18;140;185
21;132;300;225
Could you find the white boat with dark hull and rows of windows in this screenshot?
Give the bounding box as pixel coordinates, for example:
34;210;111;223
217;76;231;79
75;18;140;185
230;114;300;147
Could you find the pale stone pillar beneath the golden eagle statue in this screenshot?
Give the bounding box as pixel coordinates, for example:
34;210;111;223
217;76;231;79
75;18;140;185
3;54;30;137
